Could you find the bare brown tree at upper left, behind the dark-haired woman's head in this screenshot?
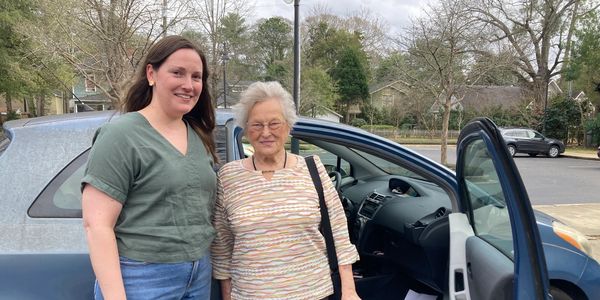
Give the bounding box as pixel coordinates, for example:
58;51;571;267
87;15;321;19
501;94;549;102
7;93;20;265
22;0;191;107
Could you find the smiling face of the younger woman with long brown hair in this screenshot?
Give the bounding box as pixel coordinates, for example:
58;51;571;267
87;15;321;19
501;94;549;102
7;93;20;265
146;49;203;117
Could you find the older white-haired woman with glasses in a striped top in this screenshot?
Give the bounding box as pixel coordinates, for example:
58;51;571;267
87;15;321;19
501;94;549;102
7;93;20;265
212;82;359;299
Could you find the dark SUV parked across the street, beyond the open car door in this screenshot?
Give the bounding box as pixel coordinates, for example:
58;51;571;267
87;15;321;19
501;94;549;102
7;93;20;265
500;128;565;158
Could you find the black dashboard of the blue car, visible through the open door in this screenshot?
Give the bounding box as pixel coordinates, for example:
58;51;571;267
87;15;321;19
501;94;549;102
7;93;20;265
341;175;451;292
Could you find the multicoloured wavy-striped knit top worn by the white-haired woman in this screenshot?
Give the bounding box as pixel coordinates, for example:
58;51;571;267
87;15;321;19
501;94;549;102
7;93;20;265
211;156;358;300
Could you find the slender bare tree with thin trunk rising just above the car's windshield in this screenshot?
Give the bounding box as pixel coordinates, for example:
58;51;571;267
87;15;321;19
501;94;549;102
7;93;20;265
401;0;477;164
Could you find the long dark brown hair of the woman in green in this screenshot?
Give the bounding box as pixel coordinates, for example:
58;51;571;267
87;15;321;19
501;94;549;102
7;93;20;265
121;35;218;162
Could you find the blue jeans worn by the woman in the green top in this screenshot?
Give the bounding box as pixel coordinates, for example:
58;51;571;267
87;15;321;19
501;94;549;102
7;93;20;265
94;255;212;300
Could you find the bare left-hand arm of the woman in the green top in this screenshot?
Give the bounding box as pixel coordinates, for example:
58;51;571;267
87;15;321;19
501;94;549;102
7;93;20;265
82;184;126;300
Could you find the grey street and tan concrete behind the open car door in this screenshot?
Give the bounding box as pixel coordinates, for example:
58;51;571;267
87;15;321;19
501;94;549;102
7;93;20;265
409;145;600;261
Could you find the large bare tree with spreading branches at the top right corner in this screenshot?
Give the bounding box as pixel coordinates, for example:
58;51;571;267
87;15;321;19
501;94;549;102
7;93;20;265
470;0;598;113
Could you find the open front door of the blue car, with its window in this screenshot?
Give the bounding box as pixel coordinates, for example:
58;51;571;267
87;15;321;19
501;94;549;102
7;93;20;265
449;118;550;300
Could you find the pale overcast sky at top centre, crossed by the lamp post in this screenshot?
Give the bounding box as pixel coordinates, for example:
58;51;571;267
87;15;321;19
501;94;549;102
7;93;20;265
254;0;431;33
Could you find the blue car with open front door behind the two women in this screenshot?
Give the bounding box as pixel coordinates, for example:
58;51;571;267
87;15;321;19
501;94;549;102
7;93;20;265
0;110;600;300
